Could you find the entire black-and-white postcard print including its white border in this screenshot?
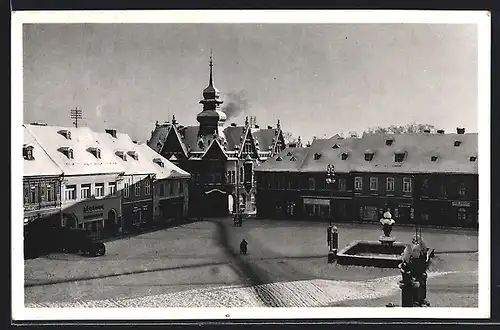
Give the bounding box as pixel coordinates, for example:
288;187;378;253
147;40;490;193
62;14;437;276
12;11;490;320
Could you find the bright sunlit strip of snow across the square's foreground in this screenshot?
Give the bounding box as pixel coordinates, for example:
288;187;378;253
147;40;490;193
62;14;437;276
26;272;472;308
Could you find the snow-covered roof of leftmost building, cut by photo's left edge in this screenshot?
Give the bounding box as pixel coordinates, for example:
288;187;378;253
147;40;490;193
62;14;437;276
23;126;62;176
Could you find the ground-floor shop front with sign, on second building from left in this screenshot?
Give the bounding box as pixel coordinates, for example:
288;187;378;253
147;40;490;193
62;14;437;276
63;197;121;236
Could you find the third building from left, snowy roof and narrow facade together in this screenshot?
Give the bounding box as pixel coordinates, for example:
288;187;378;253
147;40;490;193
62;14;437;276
97;129;155;231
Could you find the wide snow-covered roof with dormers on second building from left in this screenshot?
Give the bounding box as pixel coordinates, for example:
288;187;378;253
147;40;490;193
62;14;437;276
23;125;124;175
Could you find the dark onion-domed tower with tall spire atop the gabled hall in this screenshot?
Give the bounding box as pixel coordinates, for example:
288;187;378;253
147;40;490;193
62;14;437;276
196;53;227;136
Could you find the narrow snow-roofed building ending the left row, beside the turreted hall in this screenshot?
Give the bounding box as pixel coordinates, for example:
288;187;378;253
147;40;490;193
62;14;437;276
140;144;191;224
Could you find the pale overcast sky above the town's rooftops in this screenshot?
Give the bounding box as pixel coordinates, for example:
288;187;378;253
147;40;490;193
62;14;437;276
23;24;478;141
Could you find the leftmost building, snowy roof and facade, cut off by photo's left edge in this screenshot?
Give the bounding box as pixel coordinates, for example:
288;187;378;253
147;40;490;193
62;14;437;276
23;127;63;227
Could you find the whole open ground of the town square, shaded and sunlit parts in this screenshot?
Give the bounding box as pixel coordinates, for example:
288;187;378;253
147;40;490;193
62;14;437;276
25;219;477;307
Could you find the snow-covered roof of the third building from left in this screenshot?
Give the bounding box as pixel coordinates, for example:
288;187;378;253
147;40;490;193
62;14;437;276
95;132;156;175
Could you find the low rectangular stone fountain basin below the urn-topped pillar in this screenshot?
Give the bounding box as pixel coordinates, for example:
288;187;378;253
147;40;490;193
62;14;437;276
337;241;406;268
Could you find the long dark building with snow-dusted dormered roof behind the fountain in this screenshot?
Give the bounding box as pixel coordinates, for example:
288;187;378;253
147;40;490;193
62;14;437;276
256;129;478;227
